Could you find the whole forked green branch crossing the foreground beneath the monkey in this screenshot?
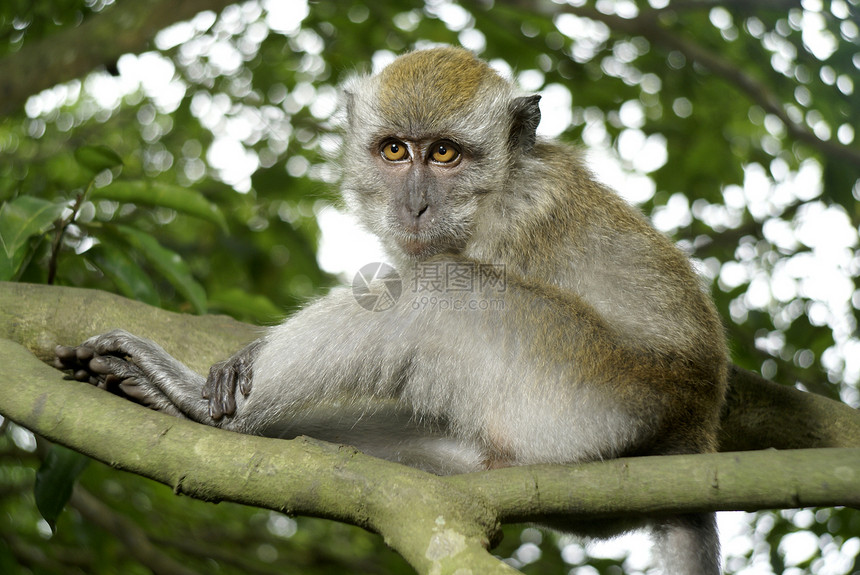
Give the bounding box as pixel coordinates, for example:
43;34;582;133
0;340;860;573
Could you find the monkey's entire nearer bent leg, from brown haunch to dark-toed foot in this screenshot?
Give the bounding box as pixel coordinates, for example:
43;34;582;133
55;257;719;465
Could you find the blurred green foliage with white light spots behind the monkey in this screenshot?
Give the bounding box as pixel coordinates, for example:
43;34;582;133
0;0;860;574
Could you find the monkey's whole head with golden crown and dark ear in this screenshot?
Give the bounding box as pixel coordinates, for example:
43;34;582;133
343;47;540;259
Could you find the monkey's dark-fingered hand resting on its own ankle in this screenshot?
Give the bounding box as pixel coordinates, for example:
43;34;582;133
203;340;263;421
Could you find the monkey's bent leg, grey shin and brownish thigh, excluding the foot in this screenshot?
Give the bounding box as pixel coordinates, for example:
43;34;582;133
229;256;722;465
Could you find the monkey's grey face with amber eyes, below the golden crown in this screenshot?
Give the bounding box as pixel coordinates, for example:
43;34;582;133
343;120;510;259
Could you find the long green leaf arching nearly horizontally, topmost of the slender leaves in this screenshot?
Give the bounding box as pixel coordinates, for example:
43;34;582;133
90;180;227;232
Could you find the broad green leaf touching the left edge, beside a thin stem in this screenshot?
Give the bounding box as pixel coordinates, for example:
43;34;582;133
0;196;66;281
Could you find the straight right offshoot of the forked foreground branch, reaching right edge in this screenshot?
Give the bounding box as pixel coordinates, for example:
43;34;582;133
448;448;860;523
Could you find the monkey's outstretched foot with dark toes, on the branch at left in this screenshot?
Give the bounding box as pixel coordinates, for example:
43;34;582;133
54;330;208;421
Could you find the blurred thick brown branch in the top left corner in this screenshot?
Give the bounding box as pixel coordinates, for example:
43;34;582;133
0;0;236;116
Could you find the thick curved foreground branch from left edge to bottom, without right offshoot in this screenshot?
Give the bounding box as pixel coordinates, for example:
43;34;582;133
0;339;513;574
